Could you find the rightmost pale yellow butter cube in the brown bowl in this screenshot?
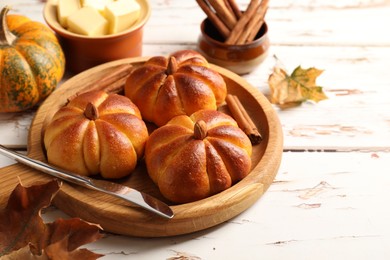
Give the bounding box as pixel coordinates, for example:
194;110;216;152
105;0;141;34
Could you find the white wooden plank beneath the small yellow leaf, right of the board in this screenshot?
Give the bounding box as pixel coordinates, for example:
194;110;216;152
246;46;390;149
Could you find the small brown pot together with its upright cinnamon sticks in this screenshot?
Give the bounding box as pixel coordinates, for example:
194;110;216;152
197;0;270;75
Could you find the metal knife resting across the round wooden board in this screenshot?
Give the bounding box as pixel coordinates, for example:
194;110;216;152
0;145;174;219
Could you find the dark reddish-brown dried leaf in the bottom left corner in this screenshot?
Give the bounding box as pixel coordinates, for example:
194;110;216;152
0;180;102;259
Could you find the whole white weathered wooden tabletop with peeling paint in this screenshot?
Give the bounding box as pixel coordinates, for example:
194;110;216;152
0;0;390;260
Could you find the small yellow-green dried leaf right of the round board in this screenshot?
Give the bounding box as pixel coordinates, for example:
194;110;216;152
268;63;327;107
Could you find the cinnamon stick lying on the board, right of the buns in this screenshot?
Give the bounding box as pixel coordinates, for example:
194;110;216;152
226;94;262;145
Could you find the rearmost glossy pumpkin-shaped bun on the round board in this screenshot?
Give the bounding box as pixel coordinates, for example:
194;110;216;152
125;50;227;126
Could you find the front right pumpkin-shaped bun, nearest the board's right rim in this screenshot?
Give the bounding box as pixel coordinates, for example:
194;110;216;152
145;110;252;203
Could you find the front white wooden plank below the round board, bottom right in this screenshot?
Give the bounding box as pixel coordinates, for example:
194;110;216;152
34;152;390;260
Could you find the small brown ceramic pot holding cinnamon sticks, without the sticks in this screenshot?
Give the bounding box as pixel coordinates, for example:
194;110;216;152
197;18;270;75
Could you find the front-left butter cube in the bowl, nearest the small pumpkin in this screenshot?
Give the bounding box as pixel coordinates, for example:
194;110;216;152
68;7;108;36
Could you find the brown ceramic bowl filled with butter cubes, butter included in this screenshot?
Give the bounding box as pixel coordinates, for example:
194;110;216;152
44;0;151;73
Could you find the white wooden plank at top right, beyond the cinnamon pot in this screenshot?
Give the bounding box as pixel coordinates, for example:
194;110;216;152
266;0;390;46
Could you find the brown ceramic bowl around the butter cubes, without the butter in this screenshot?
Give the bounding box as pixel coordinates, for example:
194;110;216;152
43;0;151;73
